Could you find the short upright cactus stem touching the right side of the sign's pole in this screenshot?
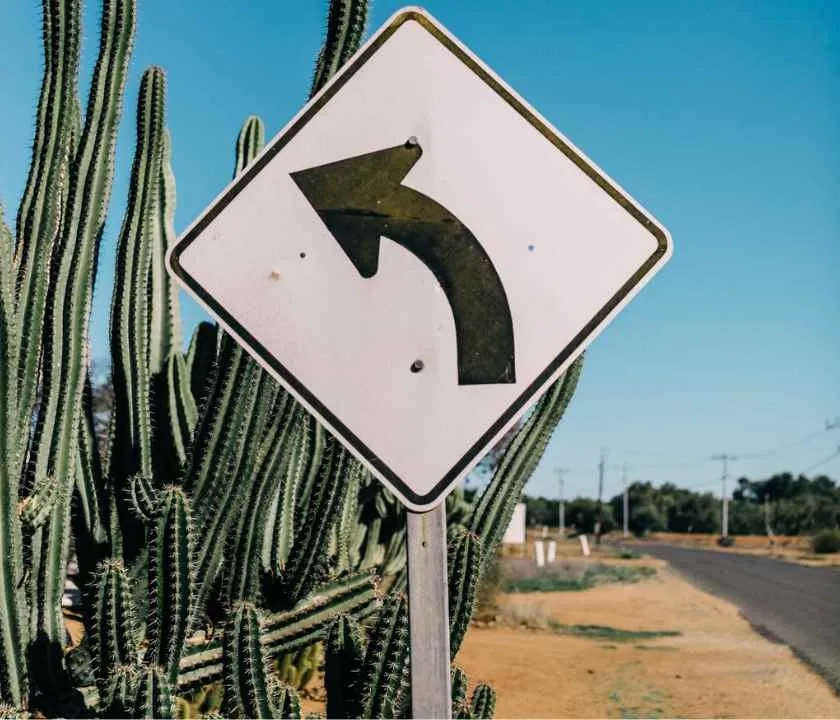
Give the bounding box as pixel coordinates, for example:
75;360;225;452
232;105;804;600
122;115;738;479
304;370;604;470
447;525;483;659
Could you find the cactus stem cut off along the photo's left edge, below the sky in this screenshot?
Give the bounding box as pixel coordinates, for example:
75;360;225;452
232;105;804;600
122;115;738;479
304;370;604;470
0;208;28;706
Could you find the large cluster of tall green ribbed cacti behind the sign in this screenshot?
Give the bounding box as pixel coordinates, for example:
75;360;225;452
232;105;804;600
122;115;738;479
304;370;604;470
0;0;579;718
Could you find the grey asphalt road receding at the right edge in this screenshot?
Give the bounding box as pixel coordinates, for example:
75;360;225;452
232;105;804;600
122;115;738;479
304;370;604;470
637;543;840;693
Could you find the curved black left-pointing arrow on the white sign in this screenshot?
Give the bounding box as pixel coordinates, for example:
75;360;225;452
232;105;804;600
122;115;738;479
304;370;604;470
291;140;516;385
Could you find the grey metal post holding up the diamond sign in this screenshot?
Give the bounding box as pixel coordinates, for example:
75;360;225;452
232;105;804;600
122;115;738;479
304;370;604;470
406;502;452;719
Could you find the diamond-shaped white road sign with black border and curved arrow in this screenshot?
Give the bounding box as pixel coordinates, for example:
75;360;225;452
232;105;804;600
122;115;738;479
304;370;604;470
168;8;671;510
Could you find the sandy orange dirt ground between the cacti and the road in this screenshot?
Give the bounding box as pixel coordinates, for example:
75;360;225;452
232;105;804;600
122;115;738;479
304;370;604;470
456;566;840;718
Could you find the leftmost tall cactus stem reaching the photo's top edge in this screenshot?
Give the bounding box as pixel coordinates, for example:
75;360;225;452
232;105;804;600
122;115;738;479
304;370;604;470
12;0;81;450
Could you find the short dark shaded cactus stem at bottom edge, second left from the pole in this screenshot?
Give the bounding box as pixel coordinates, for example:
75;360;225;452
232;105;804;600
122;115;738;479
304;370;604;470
324;615;365;718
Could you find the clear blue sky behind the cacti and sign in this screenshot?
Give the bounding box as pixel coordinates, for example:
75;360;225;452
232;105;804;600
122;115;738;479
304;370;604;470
0;0;840;496
